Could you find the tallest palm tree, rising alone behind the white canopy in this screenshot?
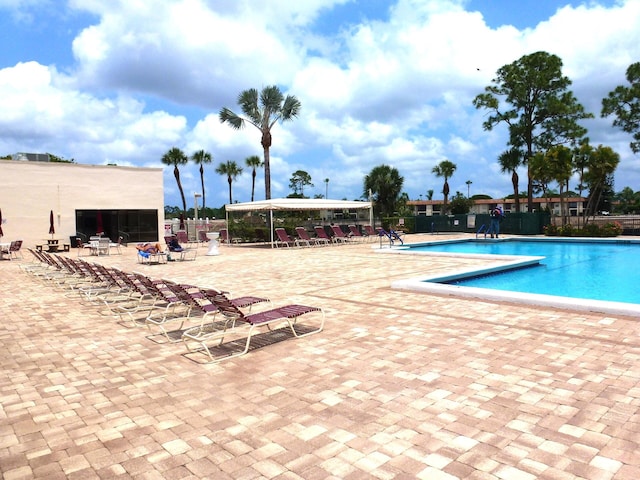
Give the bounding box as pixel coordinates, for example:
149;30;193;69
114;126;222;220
220;85;301;200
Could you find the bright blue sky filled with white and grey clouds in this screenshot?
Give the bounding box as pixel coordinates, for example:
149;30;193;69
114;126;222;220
0;0;640;206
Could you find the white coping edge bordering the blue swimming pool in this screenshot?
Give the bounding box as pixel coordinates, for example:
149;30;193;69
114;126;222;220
378;237;640;318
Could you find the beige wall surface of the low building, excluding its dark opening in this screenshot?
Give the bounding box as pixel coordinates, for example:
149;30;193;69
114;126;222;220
0;160;164;247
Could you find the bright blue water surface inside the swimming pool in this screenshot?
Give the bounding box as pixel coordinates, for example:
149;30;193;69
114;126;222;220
411;240;640;304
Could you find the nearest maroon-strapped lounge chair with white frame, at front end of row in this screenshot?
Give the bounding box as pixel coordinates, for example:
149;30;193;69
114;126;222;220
185;293;324;362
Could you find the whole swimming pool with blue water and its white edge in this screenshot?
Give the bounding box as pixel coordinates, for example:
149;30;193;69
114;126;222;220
393;238;640;316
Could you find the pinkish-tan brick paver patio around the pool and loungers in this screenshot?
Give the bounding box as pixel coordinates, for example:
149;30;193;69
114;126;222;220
0;235;640;480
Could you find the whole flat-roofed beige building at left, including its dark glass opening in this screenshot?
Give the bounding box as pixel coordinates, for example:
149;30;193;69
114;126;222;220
0;159;164;248
